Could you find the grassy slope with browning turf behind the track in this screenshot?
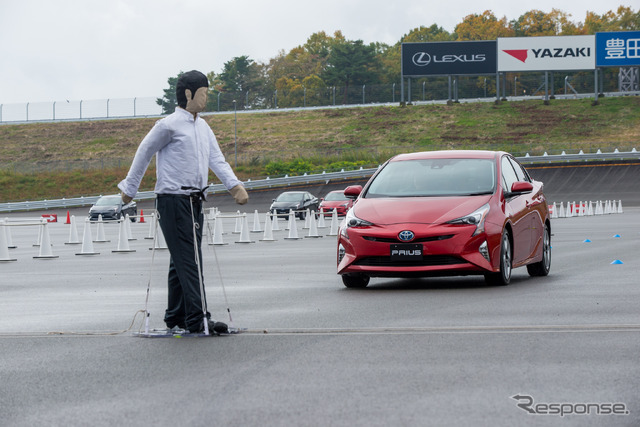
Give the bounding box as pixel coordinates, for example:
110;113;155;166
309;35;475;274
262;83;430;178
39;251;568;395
0;97;640;202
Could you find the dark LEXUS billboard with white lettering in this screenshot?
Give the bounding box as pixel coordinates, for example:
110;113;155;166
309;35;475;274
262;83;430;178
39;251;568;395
402;41;496;77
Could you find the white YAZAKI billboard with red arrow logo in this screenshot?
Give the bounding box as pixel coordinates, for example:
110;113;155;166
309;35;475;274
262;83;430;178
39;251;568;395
498;35;596;71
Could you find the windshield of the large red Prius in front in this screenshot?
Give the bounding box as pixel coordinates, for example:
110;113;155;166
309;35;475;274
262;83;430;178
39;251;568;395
365;159;496;197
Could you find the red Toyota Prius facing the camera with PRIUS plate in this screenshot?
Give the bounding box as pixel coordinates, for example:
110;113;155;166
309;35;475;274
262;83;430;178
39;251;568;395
338;150;551;288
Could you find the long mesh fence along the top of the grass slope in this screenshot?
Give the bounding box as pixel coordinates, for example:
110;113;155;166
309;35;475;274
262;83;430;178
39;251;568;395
0;68;636;123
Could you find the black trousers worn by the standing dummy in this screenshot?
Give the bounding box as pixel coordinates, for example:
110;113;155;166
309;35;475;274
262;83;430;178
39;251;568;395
157;194;211;332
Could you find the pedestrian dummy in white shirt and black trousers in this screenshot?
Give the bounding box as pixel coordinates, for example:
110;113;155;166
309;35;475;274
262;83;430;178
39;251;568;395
118;70;249;333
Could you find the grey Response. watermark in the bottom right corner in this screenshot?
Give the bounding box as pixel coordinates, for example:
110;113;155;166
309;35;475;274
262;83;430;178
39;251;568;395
511;393;630;417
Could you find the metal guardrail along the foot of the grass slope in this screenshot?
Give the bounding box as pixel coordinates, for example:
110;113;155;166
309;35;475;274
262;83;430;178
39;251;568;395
0;148;640;212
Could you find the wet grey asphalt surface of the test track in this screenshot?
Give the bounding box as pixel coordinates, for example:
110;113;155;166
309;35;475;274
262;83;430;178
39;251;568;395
0;162;640;426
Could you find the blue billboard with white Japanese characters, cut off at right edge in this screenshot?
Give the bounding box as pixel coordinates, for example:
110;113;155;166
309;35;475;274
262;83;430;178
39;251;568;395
596;31;640;67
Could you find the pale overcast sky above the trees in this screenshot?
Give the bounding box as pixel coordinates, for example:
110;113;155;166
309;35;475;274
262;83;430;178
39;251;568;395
0;0;636;104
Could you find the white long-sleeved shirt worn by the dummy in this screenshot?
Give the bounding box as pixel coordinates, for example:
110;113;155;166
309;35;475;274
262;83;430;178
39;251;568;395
118;108;241;197
